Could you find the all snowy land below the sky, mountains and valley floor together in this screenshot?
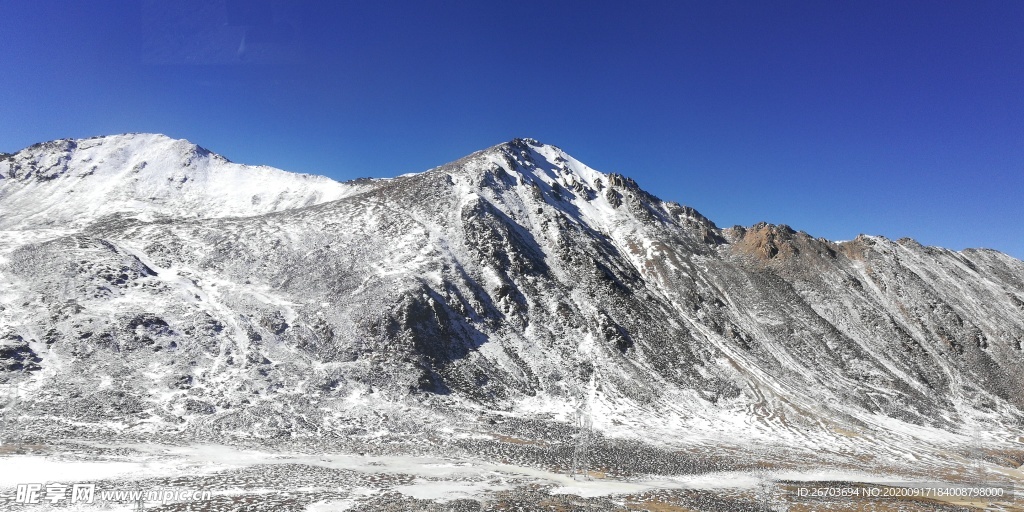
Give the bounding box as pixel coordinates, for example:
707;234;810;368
0;134;1024;511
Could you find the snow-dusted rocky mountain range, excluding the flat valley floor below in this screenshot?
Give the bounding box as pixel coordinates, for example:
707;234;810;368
0;135;1024;489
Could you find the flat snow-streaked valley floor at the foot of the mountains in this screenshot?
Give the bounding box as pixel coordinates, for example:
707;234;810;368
0;432;1024;511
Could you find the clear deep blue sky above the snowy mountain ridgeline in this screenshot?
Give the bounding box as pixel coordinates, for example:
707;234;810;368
0;0;1024;258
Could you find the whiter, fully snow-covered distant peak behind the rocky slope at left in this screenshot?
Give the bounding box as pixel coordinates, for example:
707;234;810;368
0;133;376;229
